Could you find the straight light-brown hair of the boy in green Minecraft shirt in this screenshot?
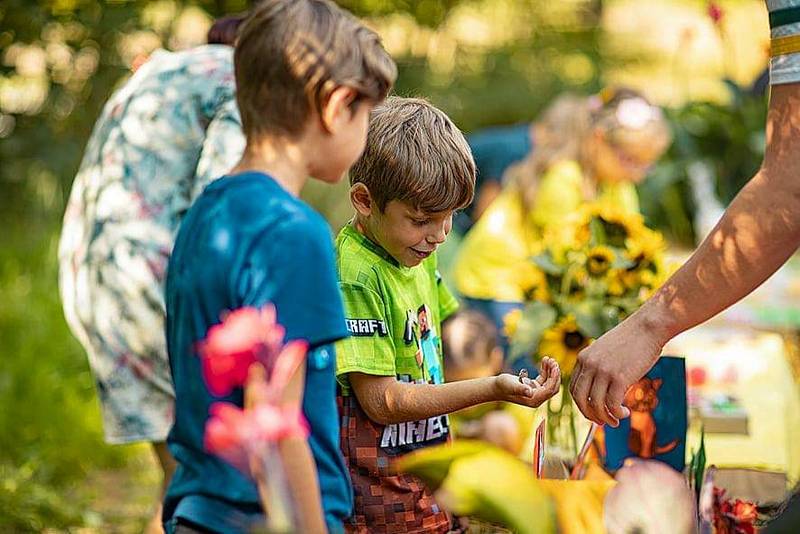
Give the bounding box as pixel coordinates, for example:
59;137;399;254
350;97;475;213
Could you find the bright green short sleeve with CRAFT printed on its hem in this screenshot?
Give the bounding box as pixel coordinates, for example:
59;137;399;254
336;282;396;384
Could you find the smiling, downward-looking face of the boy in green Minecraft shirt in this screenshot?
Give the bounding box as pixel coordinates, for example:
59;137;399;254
367;200;453;267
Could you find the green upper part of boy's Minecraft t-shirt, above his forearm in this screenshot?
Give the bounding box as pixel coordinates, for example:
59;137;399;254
336;225;458;394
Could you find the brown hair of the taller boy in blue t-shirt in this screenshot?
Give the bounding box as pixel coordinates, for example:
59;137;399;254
234;0;397;139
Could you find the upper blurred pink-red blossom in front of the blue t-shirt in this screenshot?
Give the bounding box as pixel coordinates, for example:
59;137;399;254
198;305;285;397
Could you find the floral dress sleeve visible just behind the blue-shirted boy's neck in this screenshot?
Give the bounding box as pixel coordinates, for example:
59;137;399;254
191;99;245;200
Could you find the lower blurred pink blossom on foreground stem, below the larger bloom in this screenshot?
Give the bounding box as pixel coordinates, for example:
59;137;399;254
204;402;309;475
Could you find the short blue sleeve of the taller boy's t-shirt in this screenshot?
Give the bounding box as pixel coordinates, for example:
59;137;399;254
236;214;347;348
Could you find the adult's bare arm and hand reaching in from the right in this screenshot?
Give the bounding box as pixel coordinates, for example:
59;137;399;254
570;83;800;426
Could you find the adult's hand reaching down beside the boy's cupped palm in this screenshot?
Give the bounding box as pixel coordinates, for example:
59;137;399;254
570;315;668;427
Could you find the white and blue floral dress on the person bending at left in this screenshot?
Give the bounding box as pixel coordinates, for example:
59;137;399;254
59;45;244;443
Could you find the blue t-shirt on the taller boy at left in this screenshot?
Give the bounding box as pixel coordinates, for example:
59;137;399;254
164;172;352;533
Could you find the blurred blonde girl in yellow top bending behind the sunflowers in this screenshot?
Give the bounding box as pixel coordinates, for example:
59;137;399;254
454;88;672;368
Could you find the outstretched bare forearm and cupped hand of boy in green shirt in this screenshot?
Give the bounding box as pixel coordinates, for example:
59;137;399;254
348;358;561;425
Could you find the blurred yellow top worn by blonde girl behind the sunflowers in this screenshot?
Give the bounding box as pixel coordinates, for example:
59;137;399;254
453;161;639;302
